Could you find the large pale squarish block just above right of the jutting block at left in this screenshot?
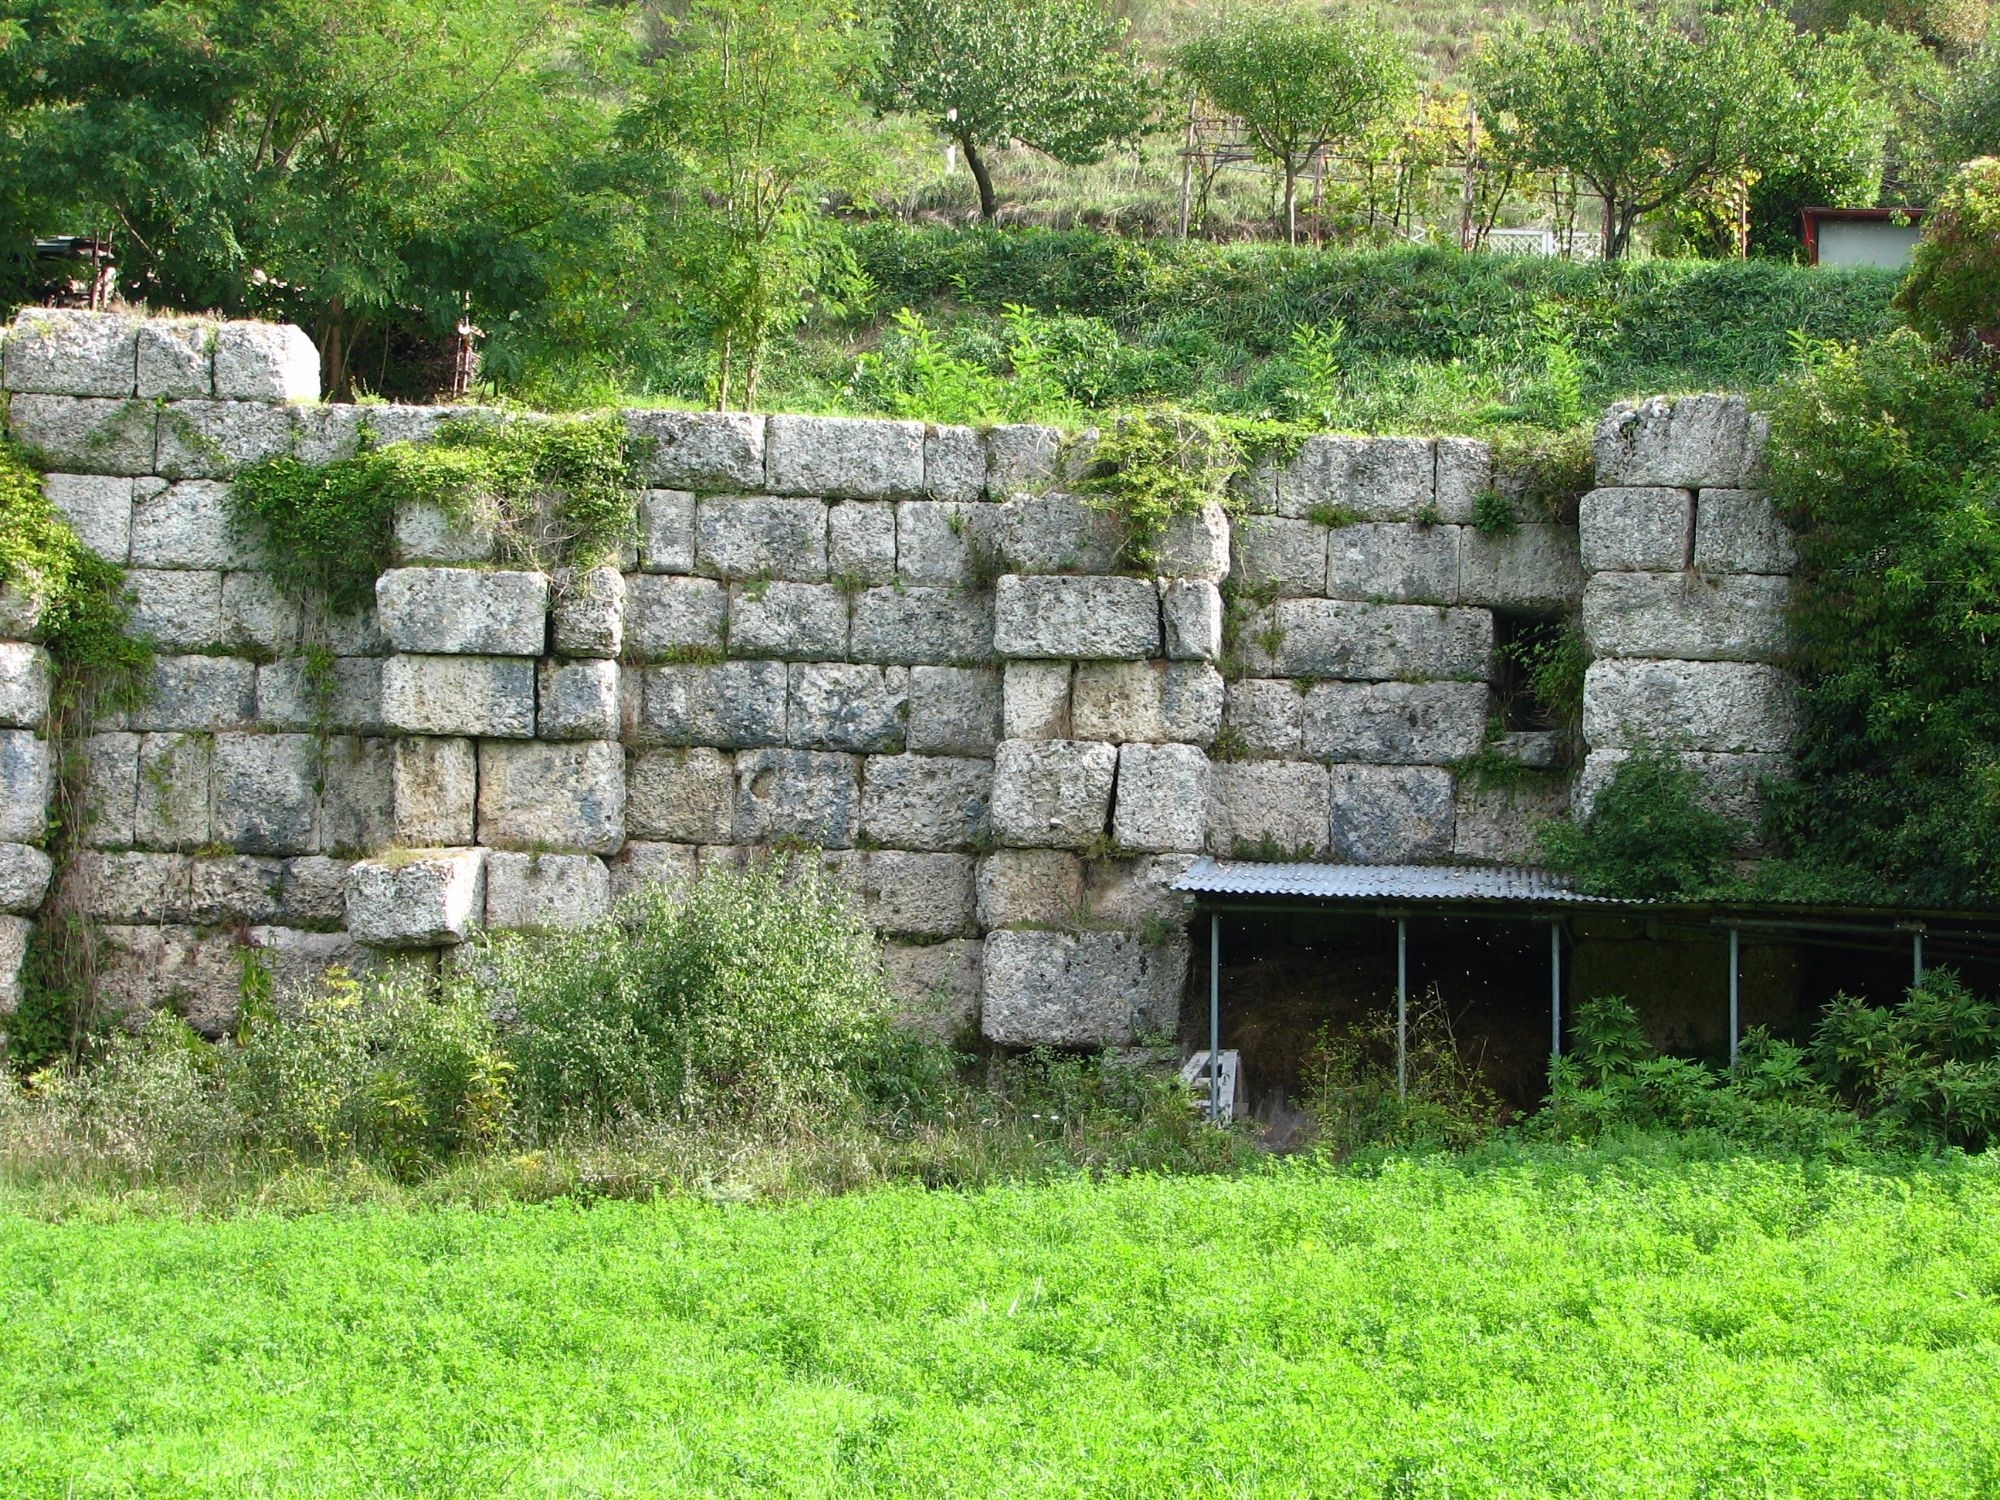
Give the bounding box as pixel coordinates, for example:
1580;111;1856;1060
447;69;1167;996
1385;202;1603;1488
480;740;624;854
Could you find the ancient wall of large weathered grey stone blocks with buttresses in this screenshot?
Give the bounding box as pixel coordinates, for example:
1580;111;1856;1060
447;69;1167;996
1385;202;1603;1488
0;310;1788;1044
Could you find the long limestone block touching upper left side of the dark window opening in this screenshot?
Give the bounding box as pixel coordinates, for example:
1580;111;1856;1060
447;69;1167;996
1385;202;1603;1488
1274;598;1494;682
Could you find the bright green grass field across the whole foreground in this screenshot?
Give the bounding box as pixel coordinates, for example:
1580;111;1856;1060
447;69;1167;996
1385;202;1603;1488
0;1152;2000;1500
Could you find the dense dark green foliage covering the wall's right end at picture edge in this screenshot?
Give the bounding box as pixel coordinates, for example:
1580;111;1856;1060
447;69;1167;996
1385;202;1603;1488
1766;332;2000;906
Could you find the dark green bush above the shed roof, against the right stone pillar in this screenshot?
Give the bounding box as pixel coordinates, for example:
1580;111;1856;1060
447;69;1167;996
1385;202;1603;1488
1540;750;1744;900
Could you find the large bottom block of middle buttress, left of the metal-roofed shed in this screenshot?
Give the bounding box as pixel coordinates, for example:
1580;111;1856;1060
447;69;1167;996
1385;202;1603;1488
980;932;1188;1046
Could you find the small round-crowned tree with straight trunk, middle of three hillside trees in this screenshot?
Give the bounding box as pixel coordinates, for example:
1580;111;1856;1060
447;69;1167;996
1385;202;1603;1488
1174;10;1412;244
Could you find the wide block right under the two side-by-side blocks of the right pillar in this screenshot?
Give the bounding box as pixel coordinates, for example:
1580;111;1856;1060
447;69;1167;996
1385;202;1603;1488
1584;572;1792;662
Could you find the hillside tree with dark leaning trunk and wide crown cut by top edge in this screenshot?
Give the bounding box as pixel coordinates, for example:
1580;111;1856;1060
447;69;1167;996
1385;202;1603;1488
872;0;1150;224
